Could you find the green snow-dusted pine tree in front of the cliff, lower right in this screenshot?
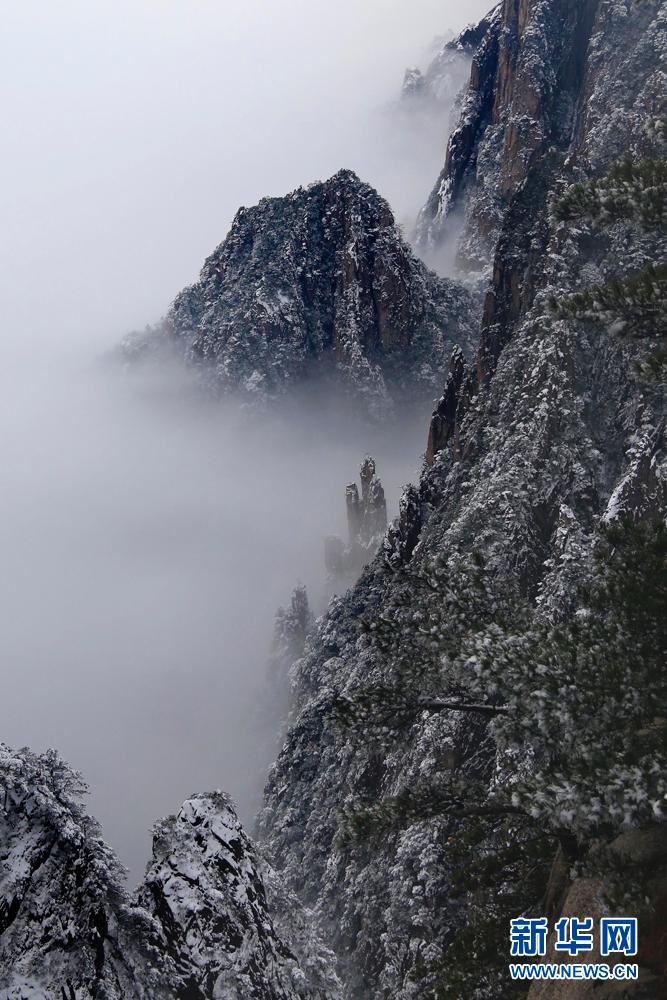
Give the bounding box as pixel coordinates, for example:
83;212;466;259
338;522;667;851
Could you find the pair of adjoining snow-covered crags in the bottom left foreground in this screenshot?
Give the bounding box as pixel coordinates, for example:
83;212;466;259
0;746;338;1000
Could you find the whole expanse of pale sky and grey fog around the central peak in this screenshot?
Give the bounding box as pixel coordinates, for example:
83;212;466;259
0;0;486;876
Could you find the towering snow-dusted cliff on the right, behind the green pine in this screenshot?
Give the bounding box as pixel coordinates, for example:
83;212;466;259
262;0;667;1000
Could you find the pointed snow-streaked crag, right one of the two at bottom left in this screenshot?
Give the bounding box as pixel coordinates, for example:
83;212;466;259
137;791;335;1000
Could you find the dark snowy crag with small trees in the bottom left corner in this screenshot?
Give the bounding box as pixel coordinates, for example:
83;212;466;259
0;744;183;1000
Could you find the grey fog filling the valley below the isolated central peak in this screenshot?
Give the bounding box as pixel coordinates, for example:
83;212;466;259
0;350;430;874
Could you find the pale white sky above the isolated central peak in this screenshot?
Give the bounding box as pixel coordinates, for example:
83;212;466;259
0;0;491;354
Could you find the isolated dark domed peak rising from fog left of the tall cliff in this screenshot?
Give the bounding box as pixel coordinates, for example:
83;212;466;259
125;170;474;416
